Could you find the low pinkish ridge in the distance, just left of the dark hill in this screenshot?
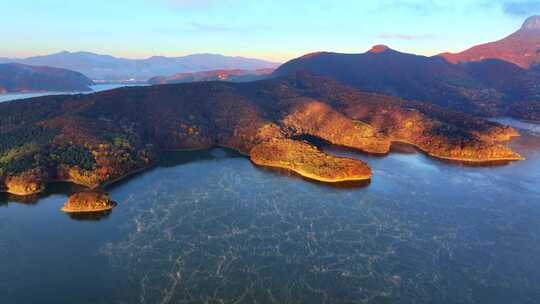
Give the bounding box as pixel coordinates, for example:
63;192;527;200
148;69;274;84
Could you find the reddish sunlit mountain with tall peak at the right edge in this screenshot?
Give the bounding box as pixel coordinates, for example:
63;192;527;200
441;16;540;68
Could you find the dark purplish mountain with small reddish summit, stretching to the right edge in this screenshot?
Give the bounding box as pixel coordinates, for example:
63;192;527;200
274;46;540;121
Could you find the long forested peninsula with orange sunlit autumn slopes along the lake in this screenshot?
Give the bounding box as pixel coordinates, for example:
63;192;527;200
0;73;522;195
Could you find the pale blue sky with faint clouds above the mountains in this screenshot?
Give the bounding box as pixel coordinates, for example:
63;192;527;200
0;0;540;62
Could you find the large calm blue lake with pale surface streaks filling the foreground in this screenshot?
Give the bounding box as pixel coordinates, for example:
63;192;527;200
0;120;540;304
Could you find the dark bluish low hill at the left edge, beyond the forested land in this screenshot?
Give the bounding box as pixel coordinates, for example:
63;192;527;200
0;63;93;93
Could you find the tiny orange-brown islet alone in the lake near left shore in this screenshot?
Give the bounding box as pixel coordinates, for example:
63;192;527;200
61;191;116;213
